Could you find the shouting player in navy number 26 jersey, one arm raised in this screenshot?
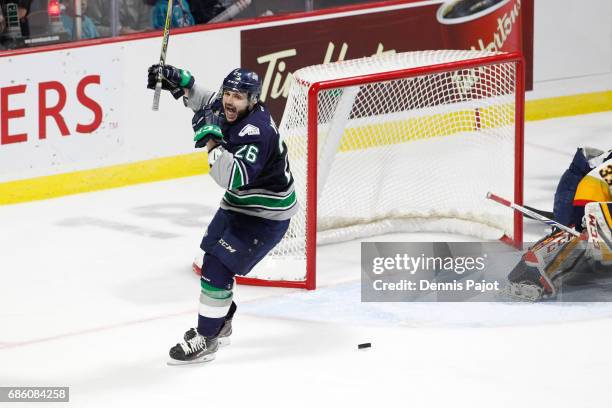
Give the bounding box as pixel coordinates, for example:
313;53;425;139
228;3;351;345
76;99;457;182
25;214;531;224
147;65;298;364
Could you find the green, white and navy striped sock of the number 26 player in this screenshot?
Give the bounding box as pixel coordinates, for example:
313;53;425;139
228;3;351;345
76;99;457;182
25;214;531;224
198;279;233;337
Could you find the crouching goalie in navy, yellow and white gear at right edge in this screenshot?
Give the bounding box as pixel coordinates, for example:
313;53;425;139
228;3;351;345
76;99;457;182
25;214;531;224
507;147;612;301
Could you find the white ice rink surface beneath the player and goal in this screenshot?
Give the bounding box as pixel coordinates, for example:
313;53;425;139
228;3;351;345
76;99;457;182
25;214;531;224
0;113;612;408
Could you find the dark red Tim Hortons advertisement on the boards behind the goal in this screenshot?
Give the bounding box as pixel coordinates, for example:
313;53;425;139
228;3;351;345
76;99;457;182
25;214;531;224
241;0;533;120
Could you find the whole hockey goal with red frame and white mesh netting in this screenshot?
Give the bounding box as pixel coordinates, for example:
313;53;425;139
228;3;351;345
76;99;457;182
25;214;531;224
239;50;524;289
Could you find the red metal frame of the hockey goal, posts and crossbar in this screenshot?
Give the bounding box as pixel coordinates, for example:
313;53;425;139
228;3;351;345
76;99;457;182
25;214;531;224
237;51;525;289
